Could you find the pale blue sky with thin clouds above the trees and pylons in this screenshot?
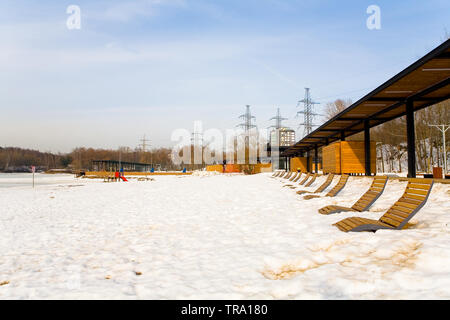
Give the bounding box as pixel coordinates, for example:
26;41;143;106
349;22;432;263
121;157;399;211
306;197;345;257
0;0;450;152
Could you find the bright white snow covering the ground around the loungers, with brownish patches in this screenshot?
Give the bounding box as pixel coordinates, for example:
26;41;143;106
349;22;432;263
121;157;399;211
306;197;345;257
0;174;450;299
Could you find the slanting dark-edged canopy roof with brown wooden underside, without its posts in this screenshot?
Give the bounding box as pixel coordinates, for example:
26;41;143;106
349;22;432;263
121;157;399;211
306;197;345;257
282;40;450;157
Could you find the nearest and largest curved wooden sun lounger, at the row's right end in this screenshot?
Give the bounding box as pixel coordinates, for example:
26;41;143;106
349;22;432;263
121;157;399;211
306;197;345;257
333;179;433;232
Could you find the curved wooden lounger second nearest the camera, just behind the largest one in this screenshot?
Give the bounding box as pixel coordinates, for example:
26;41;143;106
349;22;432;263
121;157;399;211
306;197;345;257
319;176;388;214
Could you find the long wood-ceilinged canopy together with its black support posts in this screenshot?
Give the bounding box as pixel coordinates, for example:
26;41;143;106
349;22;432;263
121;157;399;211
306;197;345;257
281;39;450;178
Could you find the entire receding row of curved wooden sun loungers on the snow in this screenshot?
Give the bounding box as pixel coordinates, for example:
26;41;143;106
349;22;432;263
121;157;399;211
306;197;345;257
273;172;433;232
